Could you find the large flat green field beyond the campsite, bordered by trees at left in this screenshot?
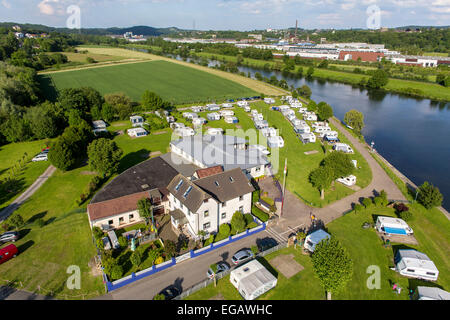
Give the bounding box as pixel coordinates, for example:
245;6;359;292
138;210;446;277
41;61;257;104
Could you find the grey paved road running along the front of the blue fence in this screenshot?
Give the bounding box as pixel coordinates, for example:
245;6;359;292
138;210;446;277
98;231;284;300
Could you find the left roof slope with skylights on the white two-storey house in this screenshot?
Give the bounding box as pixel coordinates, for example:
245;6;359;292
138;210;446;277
167;174;211;213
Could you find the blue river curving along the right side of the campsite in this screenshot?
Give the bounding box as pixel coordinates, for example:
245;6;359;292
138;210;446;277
137;48;450;210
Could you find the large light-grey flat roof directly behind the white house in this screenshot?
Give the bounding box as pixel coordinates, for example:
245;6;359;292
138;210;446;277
171;135;269;171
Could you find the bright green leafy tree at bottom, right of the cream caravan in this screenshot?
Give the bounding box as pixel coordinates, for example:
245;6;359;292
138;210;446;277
311;237;353;300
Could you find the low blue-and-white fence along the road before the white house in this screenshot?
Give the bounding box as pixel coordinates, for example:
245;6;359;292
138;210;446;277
103;222;266;292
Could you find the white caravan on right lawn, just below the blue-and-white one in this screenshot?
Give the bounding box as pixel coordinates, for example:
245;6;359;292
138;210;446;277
394;249;439;281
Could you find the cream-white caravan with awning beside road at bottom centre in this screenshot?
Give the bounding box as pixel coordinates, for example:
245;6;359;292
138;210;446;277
230;260;277;300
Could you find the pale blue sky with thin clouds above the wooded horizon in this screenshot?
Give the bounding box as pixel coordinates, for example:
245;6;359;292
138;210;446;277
0;0;450;31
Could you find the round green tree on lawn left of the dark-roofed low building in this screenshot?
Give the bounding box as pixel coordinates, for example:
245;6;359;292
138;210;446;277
88;138;123;177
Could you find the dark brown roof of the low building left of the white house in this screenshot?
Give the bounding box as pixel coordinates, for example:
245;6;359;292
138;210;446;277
91;157;178;204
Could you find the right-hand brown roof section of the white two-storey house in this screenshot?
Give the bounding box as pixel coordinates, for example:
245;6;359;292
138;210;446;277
194;168;255;203
